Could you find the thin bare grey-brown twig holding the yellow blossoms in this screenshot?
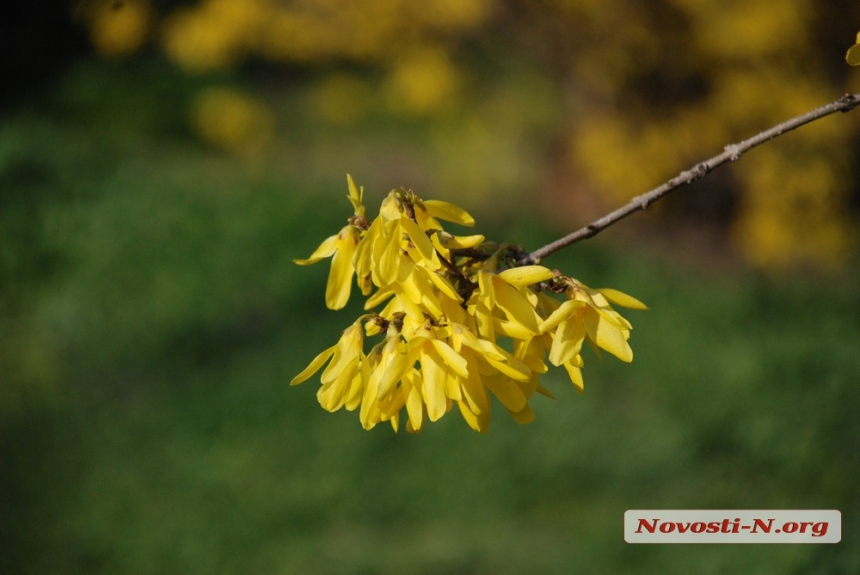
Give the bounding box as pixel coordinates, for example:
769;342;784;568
519;94;860;264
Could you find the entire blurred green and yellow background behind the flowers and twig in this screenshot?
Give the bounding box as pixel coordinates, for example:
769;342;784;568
0;0;860;575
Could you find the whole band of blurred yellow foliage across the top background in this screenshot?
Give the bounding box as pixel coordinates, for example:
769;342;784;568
79;0;860;269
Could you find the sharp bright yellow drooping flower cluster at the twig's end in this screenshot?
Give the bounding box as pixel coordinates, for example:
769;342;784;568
291;176;646;432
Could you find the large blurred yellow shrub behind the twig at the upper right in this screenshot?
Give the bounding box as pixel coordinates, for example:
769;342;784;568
560;0;860;271
